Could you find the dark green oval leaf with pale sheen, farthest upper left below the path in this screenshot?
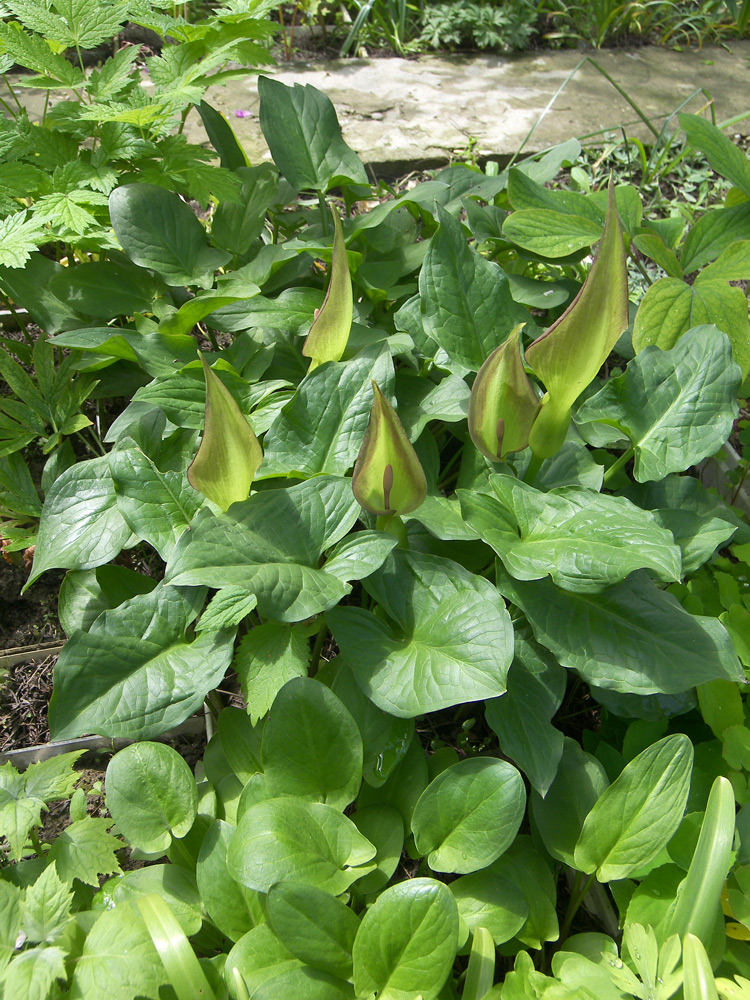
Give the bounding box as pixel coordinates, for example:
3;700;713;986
109;183;232;288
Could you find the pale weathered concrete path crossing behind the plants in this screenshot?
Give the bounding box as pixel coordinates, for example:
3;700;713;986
197;42;750;176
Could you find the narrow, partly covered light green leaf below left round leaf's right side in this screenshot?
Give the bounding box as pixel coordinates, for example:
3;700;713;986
195;819;262;941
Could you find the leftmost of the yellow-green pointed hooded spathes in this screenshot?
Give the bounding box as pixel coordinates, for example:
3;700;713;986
188;354;263;510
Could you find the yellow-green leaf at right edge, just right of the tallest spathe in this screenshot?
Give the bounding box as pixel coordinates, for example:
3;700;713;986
633;277;750;377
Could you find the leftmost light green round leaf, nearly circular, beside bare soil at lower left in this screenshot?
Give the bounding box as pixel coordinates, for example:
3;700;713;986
106;742;198;854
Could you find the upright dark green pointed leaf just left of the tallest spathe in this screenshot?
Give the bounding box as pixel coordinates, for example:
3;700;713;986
419;208;529;376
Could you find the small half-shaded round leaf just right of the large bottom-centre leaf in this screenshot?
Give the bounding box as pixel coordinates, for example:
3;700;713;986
450;871;529;945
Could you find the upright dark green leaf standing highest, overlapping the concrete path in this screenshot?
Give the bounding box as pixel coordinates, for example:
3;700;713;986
258;76;368;191
